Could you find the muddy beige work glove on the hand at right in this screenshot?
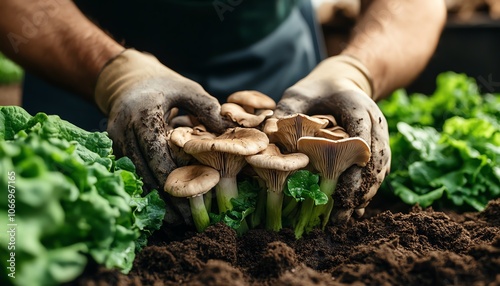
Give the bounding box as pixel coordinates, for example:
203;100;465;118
275;55;391;223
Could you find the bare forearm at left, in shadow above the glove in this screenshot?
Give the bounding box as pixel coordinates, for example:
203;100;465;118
0;0;123;99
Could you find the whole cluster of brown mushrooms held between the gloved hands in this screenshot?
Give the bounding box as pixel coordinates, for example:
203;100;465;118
164;91;371;237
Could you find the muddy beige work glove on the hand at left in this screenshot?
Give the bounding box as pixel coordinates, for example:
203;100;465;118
95;49;229;223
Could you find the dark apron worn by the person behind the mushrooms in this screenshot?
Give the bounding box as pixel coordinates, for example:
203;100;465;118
75;0;319;99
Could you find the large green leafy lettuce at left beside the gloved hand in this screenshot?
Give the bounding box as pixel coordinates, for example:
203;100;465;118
0;107;165;285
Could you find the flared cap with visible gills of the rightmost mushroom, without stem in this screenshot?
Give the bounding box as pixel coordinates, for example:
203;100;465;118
297;136;371;180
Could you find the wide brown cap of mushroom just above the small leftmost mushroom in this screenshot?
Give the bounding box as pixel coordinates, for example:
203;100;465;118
184;127;269;177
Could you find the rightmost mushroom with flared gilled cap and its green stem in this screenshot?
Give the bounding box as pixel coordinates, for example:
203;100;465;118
297;137;371;232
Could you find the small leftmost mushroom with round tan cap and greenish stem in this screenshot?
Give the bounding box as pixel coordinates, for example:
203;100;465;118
164;165;220;232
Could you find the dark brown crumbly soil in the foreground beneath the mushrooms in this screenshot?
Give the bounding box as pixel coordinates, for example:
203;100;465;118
75;199;500;286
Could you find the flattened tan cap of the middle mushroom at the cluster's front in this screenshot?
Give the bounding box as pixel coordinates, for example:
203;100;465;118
245;144;309;171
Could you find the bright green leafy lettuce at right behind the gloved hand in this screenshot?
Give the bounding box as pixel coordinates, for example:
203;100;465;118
380;73;500;211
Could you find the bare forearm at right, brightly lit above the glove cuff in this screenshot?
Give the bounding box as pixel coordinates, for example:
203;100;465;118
342;0;446;100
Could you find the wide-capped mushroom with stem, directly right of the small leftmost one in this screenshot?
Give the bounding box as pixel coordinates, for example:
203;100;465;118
184;127;269;213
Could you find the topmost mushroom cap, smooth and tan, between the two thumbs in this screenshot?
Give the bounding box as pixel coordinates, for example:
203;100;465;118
227;90;276;114
